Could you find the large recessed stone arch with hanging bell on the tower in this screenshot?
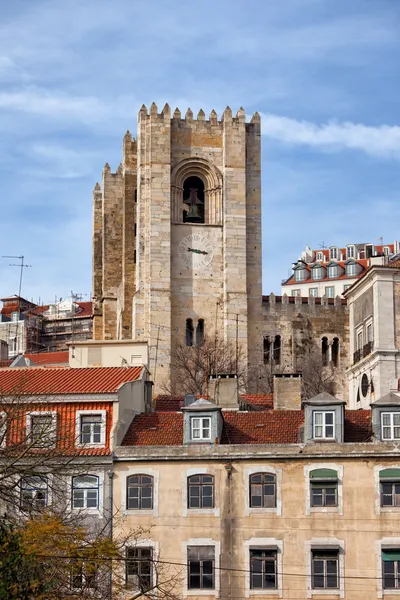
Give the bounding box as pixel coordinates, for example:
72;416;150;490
171;157;222;225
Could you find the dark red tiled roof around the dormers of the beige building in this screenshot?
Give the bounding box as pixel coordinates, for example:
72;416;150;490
122;410;372;446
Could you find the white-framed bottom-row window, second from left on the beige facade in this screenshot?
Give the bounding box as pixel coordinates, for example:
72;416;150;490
182;538;221;598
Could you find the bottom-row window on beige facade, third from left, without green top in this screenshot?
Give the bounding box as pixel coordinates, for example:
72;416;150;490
244;538;283;598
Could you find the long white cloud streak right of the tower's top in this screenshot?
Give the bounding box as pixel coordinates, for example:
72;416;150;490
262;113;400;159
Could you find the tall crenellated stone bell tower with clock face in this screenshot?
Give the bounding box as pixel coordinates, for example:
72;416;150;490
93;103;262;394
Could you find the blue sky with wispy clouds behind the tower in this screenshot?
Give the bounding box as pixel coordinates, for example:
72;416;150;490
0;0;400;302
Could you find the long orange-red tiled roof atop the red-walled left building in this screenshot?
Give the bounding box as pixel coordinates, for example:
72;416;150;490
0;367;142;396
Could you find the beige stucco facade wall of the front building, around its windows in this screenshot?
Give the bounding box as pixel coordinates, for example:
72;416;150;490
114;445;400;600
